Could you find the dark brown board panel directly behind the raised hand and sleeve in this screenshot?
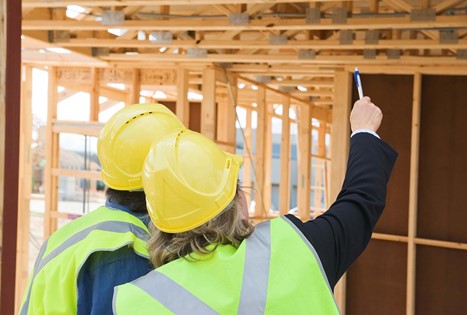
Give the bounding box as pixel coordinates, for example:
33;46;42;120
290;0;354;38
353;74;413;235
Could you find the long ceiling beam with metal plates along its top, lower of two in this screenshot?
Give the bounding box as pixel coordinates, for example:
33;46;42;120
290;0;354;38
54;38;467;50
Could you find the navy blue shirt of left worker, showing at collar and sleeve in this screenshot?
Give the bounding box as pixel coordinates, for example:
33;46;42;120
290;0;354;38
77;202;153;315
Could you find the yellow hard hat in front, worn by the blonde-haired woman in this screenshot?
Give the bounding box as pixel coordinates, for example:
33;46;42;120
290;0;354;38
143;129;243;233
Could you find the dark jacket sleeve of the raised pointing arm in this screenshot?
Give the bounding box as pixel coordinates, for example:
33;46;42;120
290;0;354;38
287;133;397;288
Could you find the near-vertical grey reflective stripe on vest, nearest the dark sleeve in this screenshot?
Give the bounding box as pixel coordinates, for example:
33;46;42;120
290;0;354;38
238;221;271;314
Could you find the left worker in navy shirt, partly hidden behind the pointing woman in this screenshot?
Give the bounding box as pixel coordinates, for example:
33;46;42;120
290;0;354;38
20;104;184;314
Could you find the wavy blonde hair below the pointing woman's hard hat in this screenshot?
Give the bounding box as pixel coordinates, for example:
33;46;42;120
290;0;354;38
148;185;254;268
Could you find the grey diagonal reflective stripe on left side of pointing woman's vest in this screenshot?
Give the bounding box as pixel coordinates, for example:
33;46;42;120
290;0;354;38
128;270;218;315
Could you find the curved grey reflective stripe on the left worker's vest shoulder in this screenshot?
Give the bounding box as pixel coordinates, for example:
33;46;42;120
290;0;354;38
20;221;149;315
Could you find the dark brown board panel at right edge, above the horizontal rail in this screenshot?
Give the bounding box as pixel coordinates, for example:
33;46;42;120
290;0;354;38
418;76;467;243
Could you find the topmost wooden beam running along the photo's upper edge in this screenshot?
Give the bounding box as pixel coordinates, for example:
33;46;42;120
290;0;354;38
22;0;338;8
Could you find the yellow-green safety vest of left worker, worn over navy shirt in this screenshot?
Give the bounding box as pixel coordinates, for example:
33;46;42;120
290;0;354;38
20;207;149;315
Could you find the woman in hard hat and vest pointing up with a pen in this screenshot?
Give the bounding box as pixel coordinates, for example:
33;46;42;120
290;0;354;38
113;97;397;315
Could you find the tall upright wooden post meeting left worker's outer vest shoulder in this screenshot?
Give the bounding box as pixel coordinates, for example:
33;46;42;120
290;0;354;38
44;67;59;239
